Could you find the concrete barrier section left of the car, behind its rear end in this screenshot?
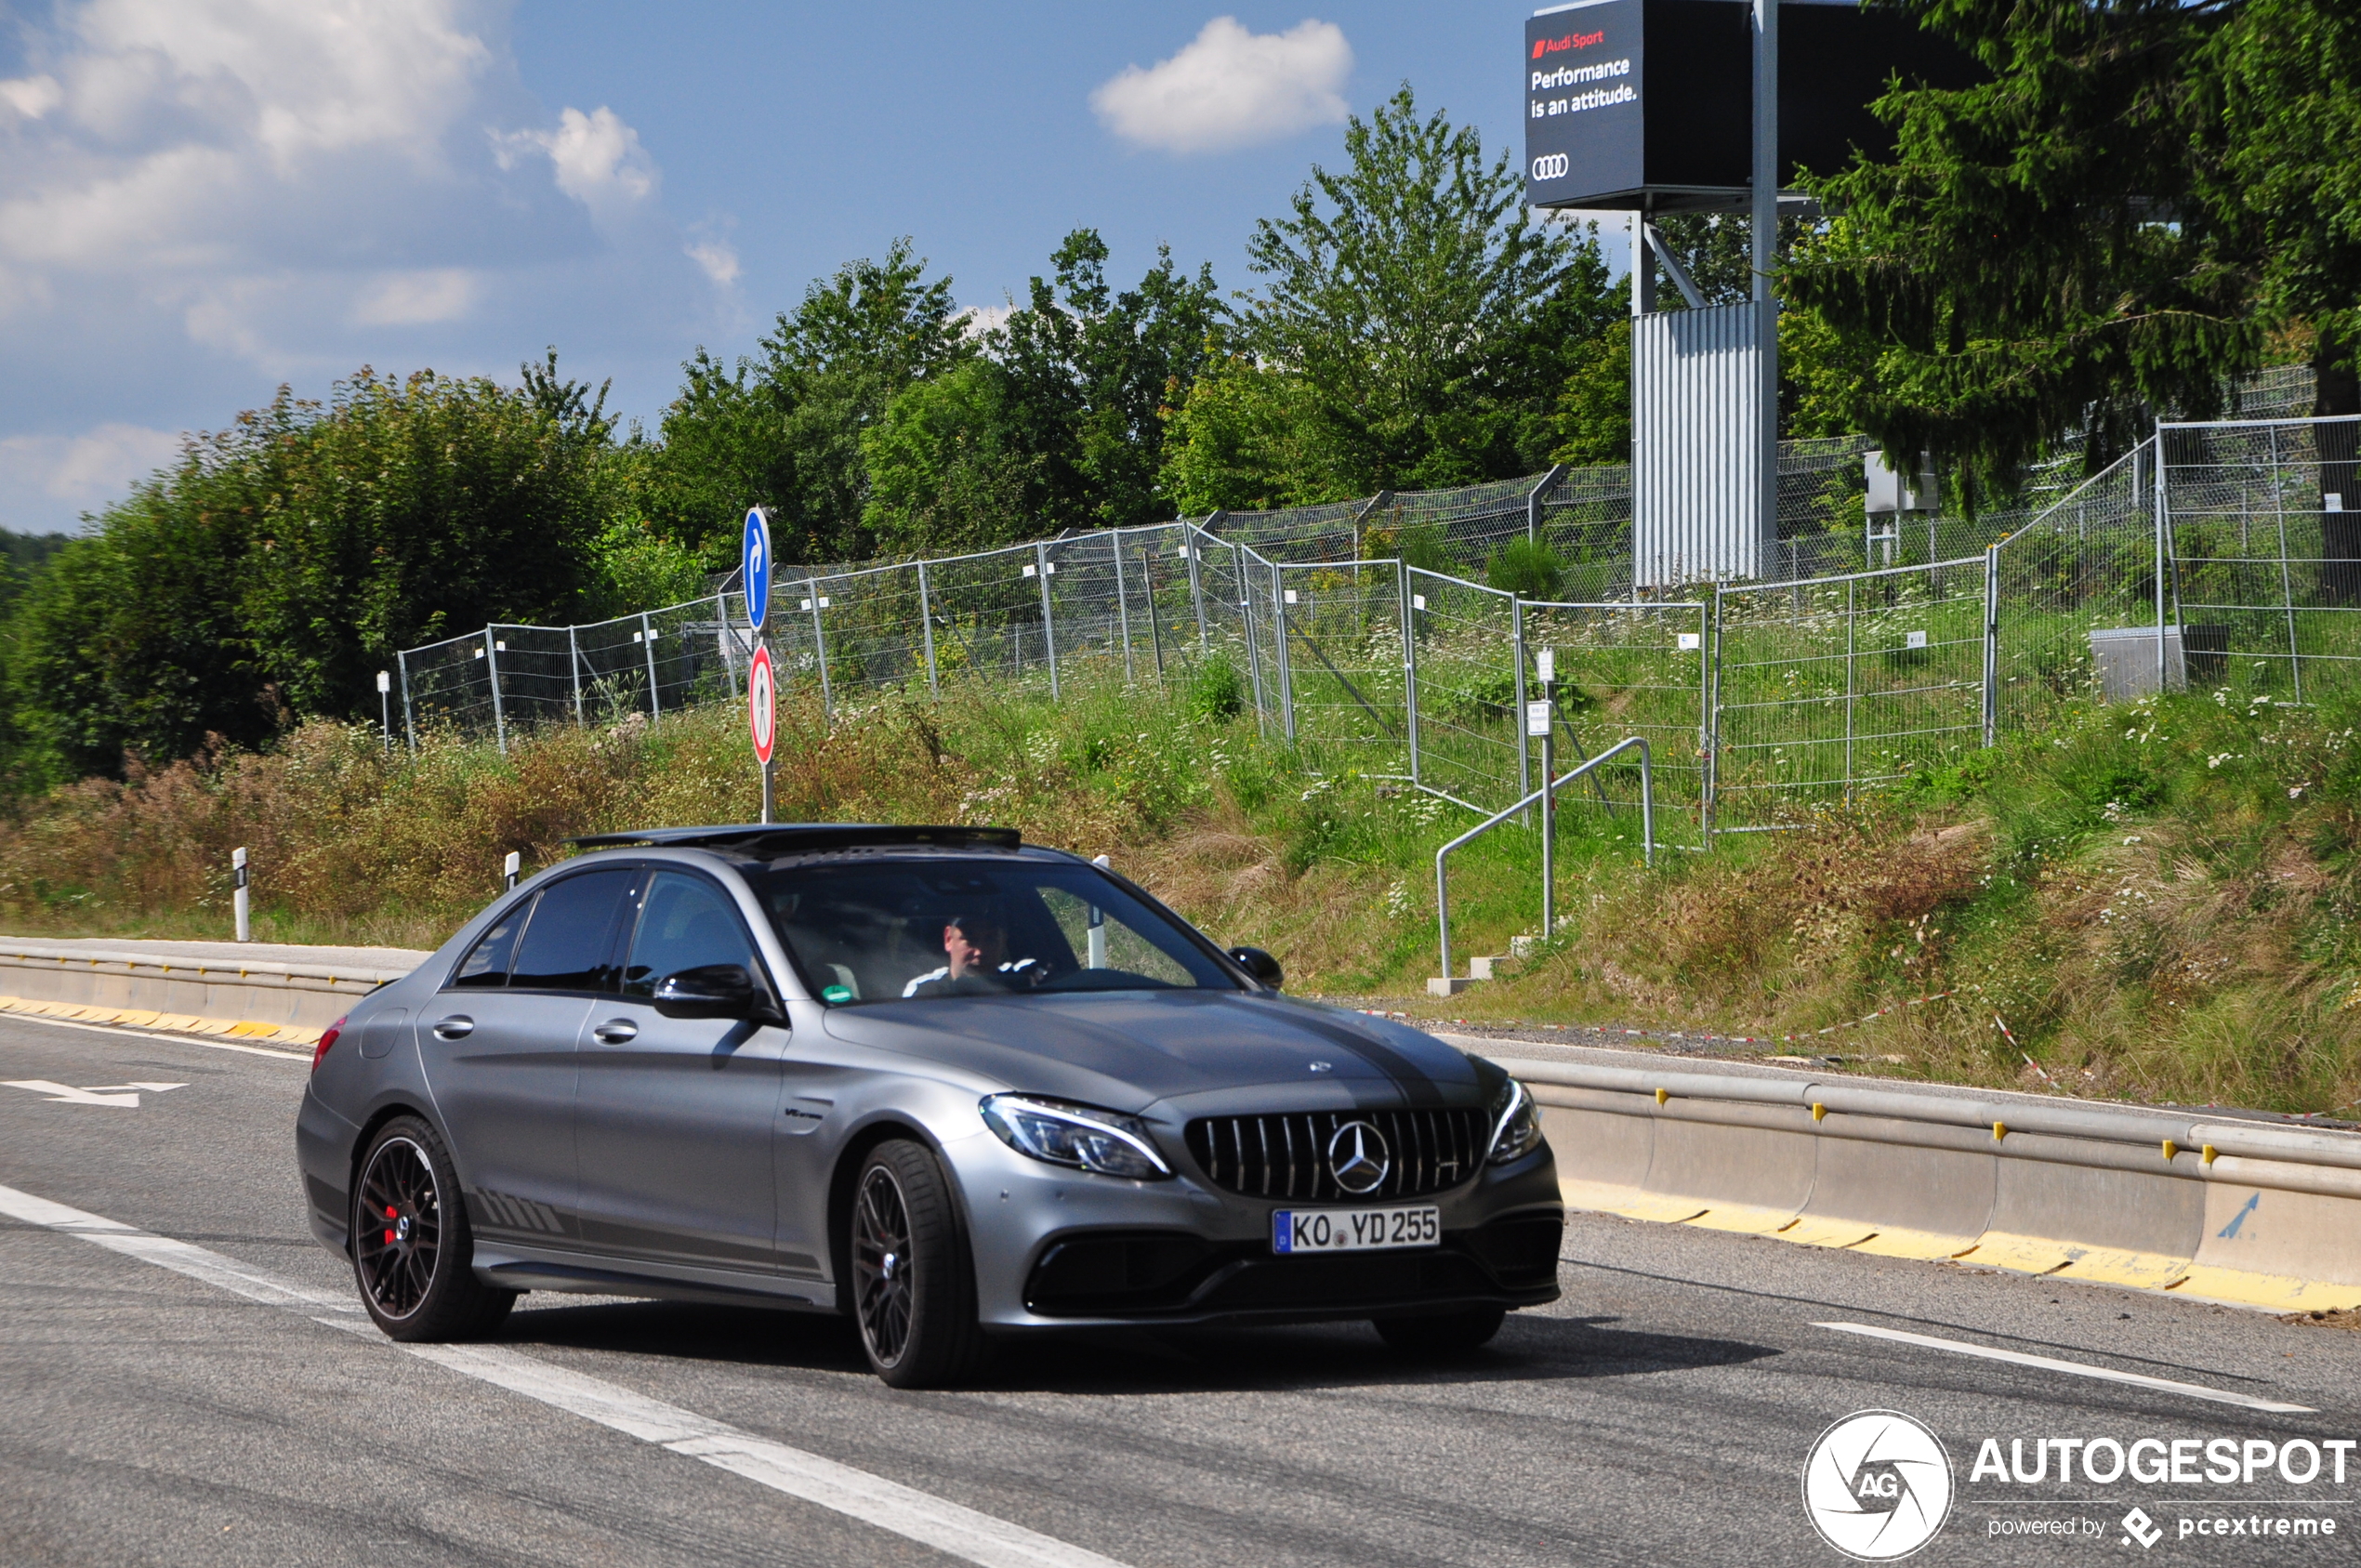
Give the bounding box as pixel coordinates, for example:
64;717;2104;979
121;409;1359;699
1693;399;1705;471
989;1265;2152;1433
0;938;428;1047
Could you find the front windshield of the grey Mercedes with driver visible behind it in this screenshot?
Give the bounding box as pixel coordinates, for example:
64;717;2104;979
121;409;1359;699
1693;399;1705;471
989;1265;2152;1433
751;857;1240;1004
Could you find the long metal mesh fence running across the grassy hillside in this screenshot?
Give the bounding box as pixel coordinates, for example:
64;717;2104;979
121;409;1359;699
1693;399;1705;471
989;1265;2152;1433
399;403;2361;846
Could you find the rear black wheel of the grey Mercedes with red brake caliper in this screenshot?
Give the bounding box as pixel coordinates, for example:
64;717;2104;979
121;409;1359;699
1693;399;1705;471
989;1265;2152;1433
351;1117;517;1341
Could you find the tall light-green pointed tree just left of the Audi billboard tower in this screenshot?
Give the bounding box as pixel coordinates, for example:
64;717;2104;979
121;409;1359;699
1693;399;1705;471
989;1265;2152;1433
1171;85;1619;498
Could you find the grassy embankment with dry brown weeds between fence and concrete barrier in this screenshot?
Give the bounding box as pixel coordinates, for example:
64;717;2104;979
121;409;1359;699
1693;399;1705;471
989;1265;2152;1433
0;656;2361;1110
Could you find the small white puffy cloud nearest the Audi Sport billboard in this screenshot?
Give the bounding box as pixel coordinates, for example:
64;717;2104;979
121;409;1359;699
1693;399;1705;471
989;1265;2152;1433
1090;17;1352;153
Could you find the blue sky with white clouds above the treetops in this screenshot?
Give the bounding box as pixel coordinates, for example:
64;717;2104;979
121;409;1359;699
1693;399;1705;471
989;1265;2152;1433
0;0;1619;529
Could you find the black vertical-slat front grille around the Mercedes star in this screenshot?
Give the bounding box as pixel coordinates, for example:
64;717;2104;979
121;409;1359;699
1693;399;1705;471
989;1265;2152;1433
1188;1110;1490;1202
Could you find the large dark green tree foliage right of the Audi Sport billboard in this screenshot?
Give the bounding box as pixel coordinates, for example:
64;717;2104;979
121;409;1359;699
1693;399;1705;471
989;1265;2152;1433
1783;0;2361;491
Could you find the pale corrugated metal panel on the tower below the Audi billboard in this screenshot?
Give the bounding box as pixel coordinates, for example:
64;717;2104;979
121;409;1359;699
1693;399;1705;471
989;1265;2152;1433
1631;305;1771;588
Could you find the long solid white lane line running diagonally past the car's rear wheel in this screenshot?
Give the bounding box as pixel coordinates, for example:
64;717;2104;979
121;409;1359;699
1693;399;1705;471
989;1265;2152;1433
0;1185;1127;1568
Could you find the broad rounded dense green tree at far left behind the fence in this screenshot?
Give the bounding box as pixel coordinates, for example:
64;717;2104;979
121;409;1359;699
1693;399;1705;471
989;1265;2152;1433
9;363;612;774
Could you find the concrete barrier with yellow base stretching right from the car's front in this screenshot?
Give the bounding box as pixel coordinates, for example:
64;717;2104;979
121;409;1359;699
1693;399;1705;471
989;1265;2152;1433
1483;1036;2361;1311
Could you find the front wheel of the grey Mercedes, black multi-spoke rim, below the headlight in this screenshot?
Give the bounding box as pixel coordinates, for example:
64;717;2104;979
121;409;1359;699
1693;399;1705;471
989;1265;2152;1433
845;1139;984;1389
